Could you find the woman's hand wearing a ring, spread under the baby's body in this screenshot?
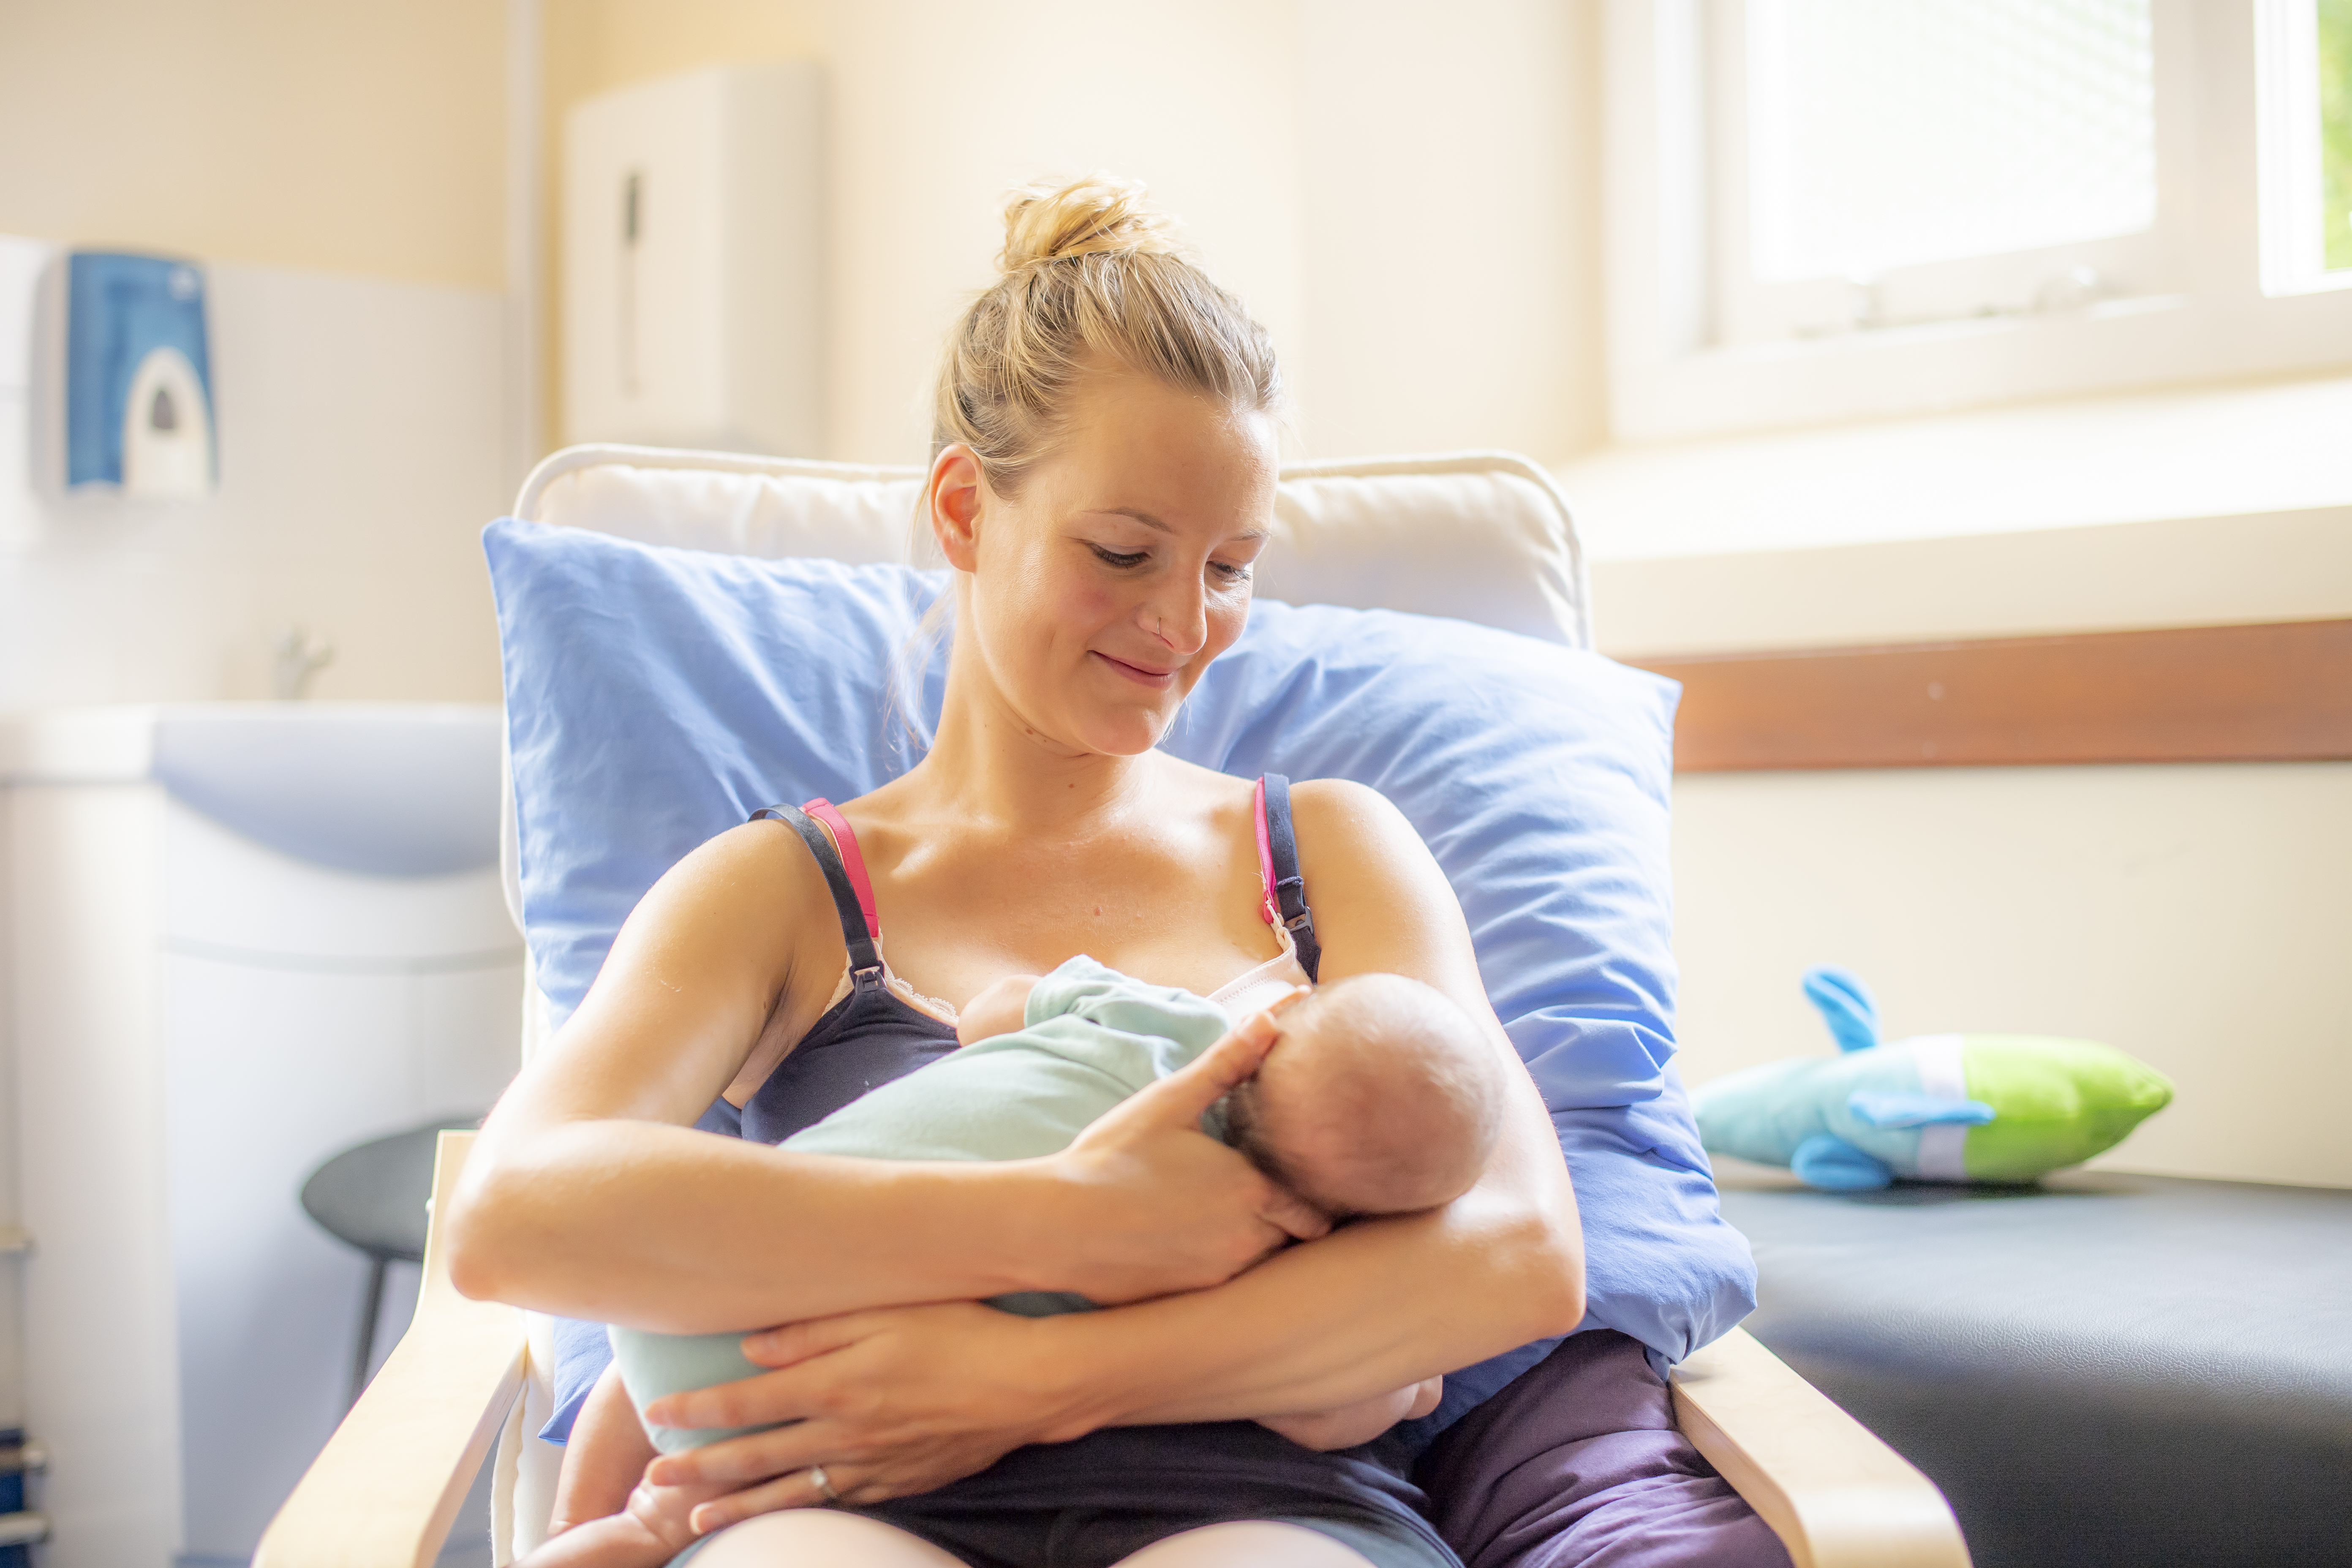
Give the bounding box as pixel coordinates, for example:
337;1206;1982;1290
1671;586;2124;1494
645;1302;1092;1535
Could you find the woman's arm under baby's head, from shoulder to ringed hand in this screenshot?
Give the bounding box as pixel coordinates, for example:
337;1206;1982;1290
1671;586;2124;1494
651;783;1583;1516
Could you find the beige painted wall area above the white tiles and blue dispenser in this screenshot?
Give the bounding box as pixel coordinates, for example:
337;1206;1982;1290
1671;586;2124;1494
0;0;506;289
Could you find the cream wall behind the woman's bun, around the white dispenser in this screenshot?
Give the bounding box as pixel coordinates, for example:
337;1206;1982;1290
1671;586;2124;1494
546;0;1599;461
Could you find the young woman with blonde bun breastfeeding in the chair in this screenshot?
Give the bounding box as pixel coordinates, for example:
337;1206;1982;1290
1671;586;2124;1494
452;181;1785;1568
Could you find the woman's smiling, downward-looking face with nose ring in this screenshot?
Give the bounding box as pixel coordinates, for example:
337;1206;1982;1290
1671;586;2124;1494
931;369;1277;757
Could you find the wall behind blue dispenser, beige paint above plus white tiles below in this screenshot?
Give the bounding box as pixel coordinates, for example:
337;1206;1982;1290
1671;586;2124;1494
0;0;515;708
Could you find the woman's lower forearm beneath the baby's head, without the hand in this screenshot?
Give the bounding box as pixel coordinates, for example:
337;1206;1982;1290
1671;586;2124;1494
1051;1157;1583;1436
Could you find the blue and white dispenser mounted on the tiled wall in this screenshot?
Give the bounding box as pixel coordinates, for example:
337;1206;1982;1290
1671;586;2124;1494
66;251;216;501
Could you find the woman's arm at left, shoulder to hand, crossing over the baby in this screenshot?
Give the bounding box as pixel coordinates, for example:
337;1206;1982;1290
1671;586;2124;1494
449;823;1310;1333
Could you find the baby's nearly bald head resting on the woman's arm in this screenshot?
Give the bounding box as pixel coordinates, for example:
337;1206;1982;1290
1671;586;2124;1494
1225;976;1505;1215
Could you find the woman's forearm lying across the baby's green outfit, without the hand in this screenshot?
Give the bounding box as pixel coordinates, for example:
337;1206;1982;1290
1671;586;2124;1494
449;1122;1051;1333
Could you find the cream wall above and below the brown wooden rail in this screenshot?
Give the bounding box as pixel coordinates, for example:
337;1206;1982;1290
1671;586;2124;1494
1592;508;2352;1187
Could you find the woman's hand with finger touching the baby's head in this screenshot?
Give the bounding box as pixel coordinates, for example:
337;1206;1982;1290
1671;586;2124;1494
1037;1013;1331;1307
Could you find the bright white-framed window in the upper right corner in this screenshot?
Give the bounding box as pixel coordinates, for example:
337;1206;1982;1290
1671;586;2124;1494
1609;0;2352;440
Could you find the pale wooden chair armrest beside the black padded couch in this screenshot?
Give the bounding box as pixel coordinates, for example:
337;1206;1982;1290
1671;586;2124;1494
1674;1328;1968;1568
